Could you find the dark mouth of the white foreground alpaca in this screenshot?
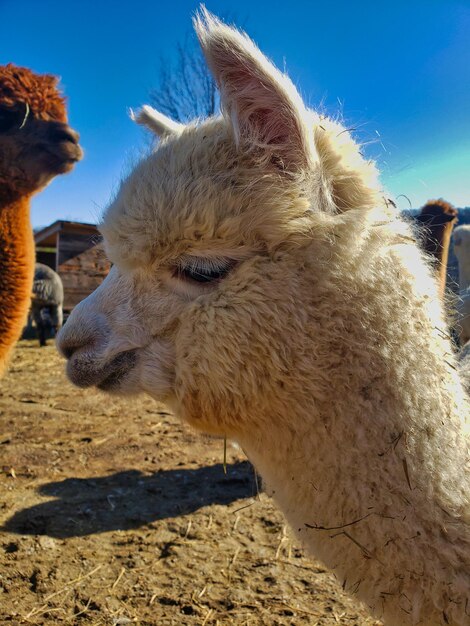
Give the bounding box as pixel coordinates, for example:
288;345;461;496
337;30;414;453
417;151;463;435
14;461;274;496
67;350;137;391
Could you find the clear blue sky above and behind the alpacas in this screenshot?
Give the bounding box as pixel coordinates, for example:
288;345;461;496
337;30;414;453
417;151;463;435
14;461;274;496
0;0;470;226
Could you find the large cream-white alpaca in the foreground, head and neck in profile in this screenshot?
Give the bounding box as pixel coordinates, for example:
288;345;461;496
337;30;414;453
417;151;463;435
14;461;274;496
59;14;470;626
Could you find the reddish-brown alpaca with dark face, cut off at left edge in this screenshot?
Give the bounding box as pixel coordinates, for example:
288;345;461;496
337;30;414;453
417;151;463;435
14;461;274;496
0;63;82;375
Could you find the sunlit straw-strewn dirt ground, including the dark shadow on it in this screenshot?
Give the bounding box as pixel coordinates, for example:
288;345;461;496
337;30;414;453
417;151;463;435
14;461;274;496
0;341;380;626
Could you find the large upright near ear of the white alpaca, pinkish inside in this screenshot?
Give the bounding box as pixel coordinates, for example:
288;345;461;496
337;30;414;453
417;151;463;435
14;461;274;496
194;7;313;171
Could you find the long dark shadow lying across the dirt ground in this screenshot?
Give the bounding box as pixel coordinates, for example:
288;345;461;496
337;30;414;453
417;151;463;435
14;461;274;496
2;461;256;538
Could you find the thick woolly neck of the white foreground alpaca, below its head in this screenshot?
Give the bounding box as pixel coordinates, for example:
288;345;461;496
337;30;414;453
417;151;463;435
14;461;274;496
239;250;470;626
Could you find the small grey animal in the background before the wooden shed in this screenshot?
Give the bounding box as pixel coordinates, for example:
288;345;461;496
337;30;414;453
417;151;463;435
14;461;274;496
31;263;64;346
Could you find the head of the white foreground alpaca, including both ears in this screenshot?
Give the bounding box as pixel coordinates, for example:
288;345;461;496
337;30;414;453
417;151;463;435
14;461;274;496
58;13;379;435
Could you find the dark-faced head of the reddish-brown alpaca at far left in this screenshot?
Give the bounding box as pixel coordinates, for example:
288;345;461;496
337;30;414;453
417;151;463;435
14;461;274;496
0;63;82;197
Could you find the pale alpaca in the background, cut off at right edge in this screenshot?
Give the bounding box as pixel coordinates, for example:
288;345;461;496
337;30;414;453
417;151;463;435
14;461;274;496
453;224;470;346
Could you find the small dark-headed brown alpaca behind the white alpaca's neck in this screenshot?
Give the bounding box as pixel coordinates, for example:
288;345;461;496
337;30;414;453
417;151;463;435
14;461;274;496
416;198;458;297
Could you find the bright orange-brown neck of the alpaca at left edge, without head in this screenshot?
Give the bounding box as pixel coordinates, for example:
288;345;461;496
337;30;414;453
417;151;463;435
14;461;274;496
0;196;35;375
